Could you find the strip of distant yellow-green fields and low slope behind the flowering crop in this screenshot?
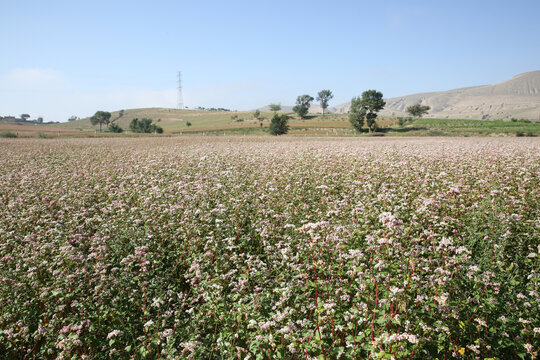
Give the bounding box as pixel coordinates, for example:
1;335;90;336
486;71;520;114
4;108;540;137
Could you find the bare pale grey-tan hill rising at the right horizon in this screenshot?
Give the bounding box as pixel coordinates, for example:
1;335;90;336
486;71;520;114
329;71;540;120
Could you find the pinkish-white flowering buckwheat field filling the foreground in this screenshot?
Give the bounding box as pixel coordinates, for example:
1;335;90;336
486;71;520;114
0;137;540;359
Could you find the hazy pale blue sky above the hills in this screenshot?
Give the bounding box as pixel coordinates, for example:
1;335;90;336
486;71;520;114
0;0;540;121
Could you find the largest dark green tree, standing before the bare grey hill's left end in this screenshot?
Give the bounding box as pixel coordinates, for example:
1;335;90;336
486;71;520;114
349;90;386;132
